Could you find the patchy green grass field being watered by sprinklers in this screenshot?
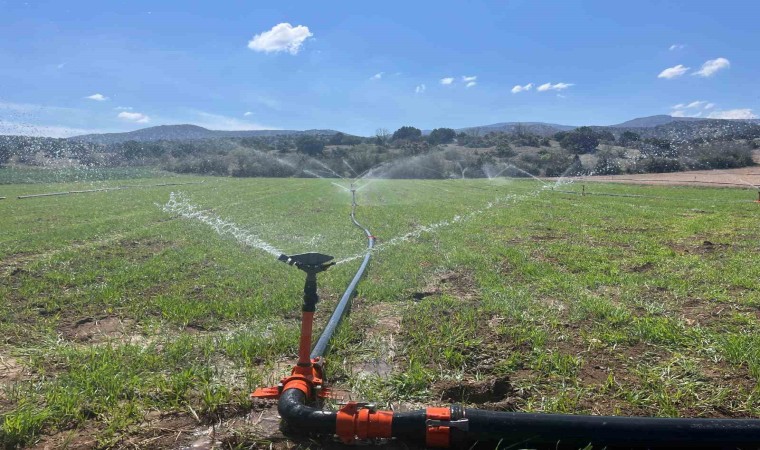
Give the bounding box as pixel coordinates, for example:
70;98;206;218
0;171;760;448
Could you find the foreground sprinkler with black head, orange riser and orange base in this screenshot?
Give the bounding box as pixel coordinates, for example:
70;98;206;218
251;253;335;398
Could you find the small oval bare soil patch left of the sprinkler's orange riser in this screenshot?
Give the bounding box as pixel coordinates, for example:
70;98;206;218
59;316;143;343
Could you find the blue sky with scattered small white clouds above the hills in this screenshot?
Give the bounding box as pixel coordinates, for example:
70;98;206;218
0;0;760;137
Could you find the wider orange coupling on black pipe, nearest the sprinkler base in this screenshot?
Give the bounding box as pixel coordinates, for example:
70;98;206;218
335;402;393;444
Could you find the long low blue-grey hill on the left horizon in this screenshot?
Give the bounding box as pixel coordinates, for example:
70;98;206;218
69;125;337;144
